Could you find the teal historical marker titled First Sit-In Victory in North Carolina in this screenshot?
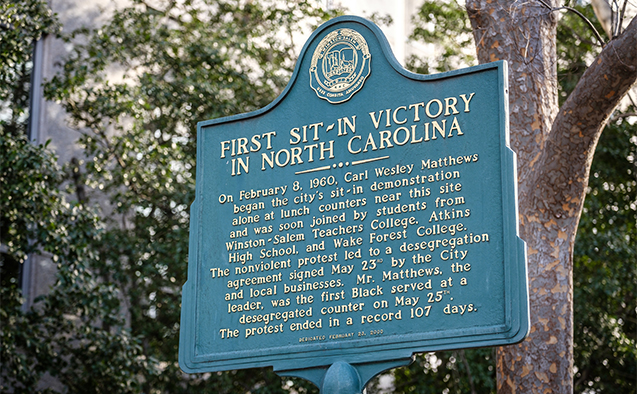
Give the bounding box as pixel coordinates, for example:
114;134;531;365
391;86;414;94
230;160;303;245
179;17;529;392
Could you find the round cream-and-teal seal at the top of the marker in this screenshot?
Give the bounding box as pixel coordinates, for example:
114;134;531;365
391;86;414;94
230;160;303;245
310;28;372;104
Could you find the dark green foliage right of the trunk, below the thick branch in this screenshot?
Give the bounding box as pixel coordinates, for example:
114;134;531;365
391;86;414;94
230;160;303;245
573;118;637;393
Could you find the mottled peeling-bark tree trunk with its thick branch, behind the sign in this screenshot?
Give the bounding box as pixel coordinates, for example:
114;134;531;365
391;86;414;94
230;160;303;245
466;0;637;394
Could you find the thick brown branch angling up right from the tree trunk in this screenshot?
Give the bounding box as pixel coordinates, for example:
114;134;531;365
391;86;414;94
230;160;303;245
533;17;637;220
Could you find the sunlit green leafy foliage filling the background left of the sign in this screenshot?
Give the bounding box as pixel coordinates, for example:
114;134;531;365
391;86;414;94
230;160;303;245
0;1;328;393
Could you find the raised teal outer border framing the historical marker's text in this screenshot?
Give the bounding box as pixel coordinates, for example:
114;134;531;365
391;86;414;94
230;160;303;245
179;16;530;376
